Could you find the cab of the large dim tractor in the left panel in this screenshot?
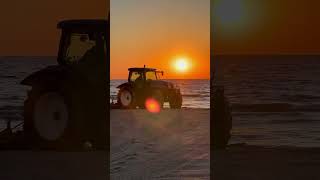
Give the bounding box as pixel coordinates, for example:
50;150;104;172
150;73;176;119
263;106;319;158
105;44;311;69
58;20;109;65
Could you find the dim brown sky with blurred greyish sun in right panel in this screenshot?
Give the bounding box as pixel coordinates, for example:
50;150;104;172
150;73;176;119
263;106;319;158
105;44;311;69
211;0;320;54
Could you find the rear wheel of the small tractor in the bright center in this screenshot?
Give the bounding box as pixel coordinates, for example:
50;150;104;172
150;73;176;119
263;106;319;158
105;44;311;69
118;88;135;109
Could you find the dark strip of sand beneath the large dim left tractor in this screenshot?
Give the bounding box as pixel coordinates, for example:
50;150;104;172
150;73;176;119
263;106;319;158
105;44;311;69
0;151;107;180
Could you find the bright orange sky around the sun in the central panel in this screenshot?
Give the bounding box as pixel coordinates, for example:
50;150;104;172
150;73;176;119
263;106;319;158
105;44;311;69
110;0;210;79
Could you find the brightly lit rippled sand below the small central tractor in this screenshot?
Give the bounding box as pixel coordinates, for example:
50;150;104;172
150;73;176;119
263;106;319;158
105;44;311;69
110;109;210;179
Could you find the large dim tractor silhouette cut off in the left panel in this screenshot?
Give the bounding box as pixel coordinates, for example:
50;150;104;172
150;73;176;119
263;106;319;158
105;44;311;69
21;20;109;148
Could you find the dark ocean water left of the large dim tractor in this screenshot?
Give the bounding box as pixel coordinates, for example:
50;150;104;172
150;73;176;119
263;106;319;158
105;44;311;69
0;57;55;130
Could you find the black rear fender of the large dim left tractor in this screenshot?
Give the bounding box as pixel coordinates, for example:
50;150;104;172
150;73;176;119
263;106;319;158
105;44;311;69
21;65;70;86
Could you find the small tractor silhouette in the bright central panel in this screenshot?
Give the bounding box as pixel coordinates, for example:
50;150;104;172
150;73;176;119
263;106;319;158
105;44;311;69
117;67;182;109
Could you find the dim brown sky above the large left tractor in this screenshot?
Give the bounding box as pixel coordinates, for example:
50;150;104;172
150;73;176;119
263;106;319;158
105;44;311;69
0;0;110;56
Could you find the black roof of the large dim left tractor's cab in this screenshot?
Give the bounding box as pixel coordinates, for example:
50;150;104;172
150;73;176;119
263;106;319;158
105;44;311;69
58;19;108;31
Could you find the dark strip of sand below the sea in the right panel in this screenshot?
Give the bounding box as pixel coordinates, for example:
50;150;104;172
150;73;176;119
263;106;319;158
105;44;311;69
212;145;320;180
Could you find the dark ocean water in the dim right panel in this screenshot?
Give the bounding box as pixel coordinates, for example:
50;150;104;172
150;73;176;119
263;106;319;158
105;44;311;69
214;56;320;147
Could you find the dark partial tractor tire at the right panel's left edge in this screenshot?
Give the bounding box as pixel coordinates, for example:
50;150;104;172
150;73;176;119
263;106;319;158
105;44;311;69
211;88;232;149
